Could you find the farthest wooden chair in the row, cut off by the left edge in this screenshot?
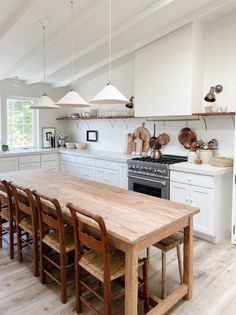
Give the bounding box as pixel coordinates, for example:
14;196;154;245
0;180;16;259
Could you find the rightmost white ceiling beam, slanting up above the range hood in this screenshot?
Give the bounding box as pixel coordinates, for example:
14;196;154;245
53;0;235;87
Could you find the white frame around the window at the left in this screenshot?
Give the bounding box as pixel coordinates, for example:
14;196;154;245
5;95;39;150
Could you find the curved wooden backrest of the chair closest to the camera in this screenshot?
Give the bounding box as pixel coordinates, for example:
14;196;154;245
66;203;110;280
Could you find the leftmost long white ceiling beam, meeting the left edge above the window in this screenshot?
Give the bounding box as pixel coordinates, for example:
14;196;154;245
0;0;107;83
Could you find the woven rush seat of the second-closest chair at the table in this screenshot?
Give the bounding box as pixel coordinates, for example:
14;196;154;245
43;226;75;253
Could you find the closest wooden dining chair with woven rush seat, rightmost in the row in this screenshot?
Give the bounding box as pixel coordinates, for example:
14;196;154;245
67;203;149;315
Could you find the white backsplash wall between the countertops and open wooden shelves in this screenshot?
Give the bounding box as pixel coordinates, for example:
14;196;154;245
69;116;234;157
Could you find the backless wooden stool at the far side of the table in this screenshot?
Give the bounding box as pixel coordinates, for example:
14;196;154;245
148;232;183;299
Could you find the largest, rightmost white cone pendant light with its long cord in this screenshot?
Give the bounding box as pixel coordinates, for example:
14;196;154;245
90;0;129;104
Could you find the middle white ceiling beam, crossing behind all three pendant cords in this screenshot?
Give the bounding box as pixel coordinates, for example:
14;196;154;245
26;0;174;84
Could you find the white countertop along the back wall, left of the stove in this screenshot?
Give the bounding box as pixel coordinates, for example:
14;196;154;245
59;148;132;162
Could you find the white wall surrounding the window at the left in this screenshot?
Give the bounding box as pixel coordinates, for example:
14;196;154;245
0;79;68;147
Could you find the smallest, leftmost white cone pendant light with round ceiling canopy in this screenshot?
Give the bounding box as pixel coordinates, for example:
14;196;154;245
30;20;60;109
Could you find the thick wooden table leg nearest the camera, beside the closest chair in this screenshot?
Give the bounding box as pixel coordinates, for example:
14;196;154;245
125;246;138;315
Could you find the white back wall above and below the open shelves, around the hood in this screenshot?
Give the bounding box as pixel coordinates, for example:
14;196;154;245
68;12;236;157
